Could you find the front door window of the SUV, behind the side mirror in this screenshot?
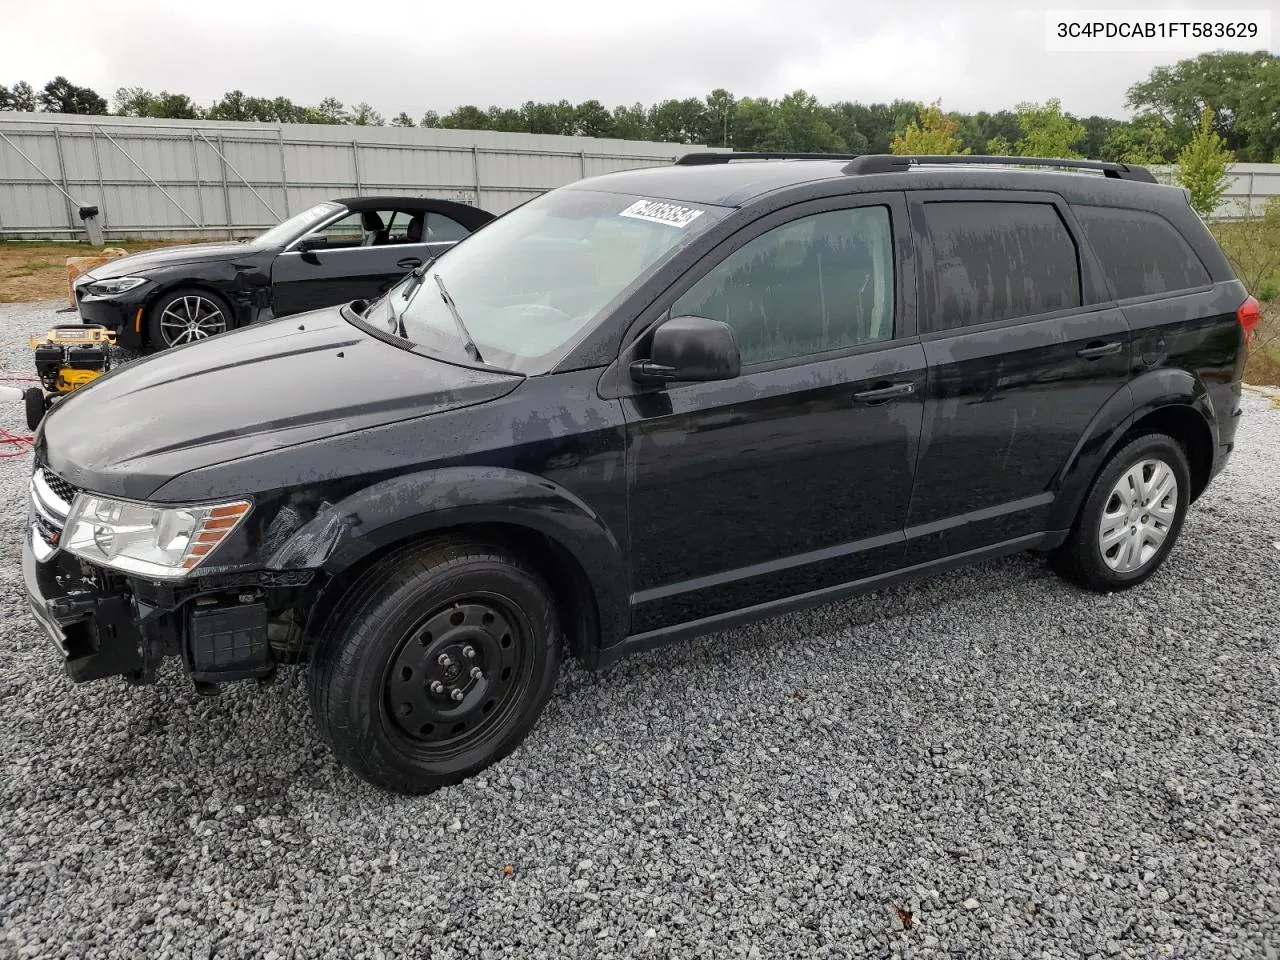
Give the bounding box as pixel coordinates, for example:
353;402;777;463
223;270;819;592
672;206;893;365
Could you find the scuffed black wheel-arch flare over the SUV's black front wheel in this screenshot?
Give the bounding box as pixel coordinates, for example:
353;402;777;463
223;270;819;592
265;466;630;645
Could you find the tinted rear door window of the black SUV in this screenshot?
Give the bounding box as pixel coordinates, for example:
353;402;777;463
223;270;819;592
923;201;1080;333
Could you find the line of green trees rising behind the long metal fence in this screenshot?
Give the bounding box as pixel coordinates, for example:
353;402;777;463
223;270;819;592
0;51;1280;164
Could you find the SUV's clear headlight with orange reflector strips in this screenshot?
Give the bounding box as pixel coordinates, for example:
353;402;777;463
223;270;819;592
61;493;250;580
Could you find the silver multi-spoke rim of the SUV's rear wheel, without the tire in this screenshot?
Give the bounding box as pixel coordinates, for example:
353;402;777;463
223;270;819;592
1098;458;1178;573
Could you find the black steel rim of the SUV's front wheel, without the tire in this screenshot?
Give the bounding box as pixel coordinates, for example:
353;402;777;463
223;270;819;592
383;595;532;763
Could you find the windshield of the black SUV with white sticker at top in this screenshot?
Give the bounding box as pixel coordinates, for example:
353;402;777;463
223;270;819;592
366;189;724;374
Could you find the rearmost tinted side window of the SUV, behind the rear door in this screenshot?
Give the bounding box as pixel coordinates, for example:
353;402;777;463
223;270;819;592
1071;204;1210;300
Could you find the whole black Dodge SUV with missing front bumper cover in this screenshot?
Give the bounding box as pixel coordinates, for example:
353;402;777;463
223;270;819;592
23;154;1257;791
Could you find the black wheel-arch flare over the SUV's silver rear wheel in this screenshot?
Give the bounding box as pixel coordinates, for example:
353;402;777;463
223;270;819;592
1050;367;1217;530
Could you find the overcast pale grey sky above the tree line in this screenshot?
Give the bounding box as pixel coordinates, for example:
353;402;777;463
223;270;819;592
0;0;1280;119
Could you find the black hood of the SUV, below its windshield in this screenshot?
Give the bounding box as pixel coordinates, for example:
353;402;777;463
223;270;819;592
36;308;524;499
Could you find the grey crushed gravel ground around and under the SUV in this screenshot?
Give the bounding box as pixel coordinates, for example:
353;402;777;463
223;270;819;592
0;306;1280;960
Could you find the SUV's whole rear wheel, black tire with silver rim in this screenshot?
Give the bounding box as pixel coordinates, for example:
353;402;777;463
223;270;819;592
1050;433;1192;593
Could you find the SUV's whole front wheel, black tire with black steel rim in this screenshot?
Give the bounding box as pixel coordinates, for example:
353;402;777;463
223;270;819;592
310;541;561;794
